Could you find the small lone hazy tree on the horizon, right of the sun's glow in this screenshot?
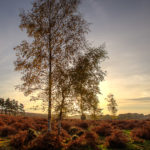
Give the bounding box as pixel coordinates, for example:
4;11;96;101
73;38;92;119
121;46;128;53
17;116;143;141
106;94;117;116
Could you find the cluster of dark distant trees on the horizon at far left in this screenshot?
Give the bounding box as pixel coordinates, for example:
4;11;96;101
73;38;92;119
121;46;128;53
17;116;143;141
0;98;25;115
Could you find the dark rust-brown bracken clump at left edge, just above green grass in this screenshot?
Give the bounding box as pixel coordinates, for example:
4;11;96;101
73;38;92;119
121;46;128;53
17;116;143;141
0;125;17;137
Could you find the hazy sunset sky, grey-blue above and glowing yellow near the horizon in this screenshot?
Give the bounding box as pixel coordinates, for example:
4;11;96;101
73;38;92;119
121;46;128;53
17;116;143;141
0;0;150;114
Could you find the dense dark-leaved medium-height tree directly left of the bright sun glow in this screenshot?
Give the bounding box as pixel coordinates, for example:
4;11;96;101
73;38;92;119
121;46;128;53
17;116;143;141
71;46;107;119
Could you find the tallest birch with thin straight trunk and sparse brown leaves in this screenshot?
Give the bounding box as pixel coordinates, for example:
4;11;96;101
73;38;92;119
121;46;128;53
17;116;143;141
15;0;88;131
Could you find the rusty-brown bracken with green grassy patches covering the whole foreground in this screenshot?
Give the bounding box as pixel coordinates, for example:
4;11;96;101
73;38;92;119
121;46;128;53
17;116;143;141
0;115;150;150
